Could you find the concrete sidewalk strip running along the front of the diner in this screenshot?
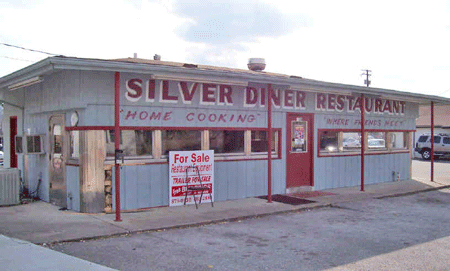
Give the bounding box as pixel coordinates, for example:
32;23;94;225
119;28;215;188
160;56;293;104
0;180;450;244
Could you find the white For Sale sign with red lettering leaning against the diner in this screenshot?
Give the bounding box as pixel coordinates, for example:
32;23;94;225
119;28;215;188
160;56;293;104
169;150;214;206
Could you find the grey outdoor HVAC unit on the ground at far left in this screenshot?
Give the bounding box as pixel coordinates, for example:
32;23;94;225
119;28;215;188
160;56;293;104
0;168;20;206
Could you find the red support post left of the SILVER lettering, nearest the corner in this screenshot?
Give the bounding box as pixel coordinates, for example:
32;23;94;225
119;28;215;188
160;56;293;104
114;72;122;222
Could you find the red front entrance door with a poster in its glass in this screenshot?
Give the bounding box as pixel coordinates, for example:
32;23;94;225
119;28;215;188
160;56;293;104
286;113;314;189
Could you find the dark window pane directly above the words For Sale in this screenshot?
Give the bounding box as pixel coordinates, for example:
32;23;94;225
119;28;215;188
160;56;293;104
161;130;202;155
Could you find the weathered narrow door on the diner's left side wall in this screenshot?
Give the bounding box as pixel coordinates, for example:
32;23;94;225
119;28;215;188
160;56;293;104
49;115;67;207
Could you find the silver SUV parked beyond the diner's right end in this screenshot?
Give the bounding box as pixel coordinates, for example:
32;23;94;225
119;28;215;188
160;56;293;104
414;134;450;160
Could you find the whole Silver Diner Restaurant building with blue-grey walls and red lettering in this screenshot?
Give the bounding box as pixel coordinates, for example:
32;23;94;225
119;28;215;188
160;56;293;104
0;56;450;213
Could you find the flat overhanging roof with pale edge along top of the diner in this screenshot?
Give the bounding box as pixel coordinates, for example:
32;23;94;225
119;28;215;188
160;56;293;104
0;56;450;104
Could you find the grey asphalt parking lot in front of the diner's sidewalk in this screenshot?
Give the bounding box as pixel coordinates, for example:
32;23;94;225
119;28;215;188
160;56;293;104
52;189;450;270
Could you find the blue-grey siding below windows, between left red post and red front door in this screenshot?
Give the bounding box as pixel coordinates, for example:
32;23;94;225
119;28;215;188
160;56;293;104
113;160;285;210
